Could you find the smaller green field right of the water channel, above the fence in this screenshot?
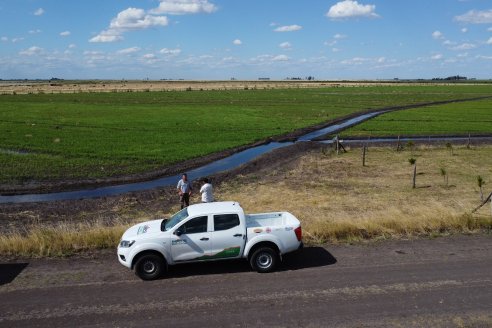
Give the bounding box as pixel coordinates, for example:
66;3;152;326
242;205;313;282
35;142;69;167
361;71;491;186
342;99;492;137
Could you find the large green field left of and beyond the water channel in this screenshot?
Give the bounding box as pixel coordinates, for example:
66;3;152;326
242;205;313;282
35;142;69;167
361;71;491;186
0;85;492;184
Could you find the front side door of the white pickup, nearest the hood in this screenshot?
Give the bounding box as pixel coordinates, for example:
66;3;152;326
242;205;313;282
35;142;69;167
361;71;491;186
171;216;210;262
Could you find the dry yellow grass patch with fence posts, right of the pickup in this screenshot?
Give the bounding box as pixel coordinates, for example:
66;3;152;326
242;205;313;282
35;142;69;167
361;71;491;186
218;146;492;243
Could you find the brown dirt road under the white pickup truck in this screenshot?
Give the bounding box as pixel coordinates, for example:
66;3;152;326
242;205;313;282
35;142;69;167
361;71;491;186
0;235;492;327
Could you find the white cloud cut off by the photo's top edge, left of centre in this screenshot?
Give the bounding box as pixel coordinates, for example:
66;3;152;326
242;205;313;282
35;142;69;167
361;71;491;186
151;0;217;15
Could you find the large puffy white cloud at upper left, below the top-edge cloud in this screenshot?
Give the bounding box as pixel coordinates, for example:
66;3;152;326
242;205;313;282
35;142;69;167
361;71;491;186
89;8;169;42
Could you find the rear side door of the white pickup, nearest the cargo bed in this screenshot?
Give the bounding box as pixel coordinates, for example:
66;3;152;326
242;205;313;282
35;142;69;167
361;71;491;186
210;214;246;259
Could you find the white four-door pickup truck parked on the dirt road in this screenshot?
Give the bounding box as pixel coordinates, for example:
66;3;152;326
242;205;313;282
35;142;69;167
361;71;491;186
118;202;302;280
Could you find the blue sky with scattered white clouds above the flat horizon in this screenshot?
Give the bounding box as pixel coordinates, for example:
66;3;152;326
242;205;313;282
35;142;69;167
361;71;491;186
0;0;492;80
